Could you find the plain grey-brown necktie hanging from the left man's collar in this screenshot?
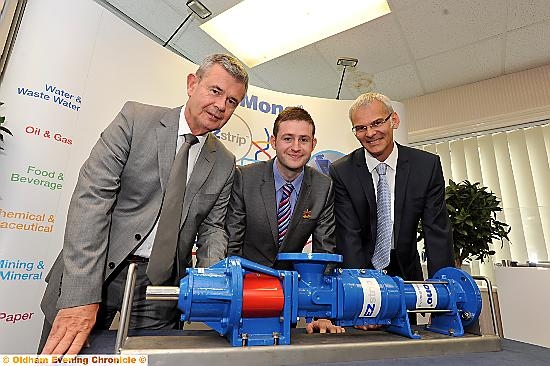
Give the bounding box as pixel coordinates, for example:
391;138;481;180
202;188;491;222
146;133;199;285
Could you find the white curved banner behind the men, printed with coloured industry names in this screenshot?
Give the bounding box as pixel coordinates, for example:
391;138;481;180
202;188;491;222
0;0;407;354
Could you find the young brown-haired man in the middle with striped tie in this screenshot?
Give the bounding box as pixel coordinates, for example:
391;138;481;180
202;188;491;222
226;107;342;333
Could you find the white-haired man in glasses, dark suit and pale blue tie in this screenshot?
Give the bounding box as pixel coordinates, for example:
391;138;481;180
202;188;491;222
330;93;453;280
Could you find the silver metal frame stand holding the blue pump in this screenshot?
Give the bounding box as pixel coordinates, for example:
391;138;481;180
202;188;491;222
115;264;502;366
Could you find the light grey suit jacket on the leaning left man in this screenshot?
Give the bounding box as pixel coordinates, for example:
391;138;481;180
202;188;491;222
41;102;235;322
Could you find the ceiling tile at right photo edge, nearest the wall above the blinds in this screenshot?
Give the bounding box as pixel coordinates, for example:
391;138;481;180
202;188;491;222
505;20;550;73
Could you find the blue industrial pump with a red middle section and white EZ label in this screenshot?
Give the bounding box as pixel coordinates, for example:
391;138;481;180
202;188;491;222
148;253;482;347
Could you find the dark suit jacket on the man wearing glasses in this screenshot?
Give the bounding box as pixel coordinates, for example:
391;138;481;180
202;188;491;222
330;144;454;280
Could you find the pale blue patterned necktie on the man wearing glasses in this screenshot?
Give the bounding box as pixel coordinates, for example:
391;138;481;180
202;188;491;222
372;163;392;269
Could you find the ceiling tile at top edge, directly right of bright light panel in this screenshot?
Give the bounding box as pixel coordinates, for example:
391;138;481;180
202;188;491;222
396;0;506;59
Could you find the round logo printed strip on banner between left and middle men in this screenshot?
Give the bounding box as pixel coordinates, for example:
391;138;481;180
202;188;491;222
213;113;252;161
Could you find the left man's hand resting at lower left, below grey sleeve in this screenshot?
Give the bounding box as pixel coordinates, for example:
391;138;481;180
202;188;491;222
42;304;99;355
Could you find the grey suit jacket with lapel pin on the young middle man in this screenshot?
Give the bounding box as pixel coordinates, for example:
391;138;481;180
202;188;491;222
226;160;335;268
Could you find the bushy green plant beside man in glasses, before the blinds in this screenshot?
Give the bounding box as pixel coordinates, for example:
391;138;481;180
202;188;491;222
419;180;511;267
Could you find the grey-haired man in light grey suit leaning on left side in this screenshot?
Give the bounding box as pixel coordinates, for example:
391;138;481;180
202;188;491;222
39;54;248;354
